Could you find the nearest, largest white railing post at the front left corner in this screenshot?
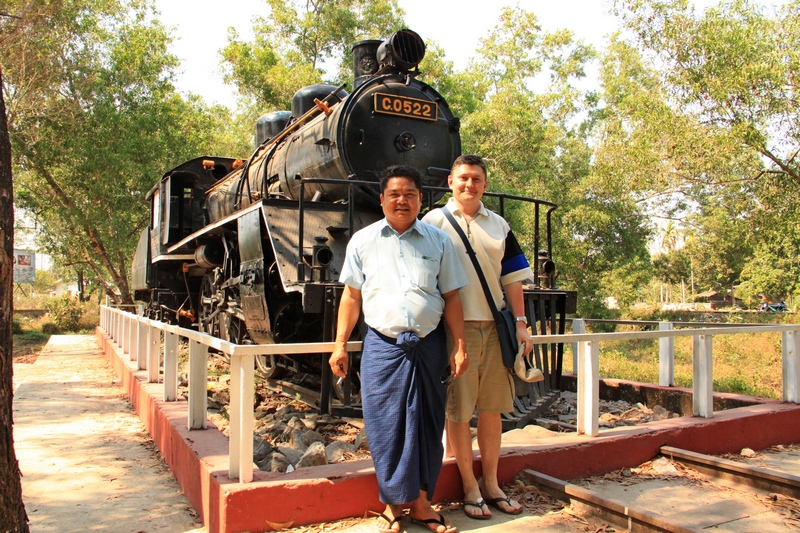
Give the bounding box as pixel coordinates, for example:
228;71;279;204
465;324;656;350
228;355;255;483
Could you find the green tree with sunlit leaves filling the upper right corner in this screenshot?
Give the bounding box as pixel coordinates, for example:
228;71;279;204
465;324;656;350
608;0;800;306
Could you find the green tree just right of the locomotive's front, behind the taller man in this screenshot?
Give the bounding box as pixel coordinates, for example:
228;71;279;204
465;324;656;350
454;8;650;316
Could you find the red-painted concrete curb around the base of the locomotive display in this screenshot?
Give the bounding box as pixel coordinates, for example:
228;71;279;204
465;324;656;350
96;328;800;533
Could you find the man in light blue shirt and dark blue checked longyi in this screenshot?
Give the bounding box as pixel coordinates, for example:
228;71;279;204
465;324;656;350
330;165;467;533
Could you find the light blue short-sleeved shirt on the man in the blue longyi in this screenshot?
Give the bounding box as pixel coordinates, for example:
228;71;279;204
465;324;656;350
339;218;467;338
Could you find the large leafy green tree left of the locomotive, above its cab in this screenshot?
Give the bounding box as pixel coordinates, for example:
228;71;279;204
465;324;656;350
0;0;242;304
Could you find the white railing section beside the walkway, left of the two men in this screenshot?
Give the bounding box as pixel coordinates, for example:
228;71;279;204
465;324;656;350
100;305;361;483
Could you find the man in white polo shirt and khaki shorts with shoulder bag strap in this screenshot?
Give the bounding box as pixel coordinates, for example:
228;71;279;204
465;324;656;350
422;155;533;520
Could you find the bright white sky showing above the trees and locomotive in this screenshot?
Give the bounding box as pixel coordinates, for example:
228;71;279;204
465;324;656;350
156;0;785;107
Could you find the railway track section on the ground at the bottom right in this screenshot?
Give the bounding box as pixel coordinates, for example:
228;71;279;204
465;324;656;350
519;446;800;533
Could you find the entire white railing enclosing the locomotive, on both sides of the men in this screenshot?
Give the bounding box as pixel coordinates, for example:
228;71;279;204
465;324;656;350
100;306;800;483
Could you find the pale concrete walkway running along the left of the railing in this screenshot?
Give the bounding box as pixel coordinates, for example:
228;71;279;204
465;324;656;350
14;335;205;533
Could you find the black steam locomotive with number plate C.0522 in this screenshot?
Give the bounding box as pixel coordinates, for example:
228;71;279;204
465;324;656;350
132;29;574;426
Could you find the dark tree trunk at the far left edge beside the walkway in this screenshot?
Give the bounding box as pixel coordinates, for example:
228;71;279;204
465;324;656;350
0;66;29;533
